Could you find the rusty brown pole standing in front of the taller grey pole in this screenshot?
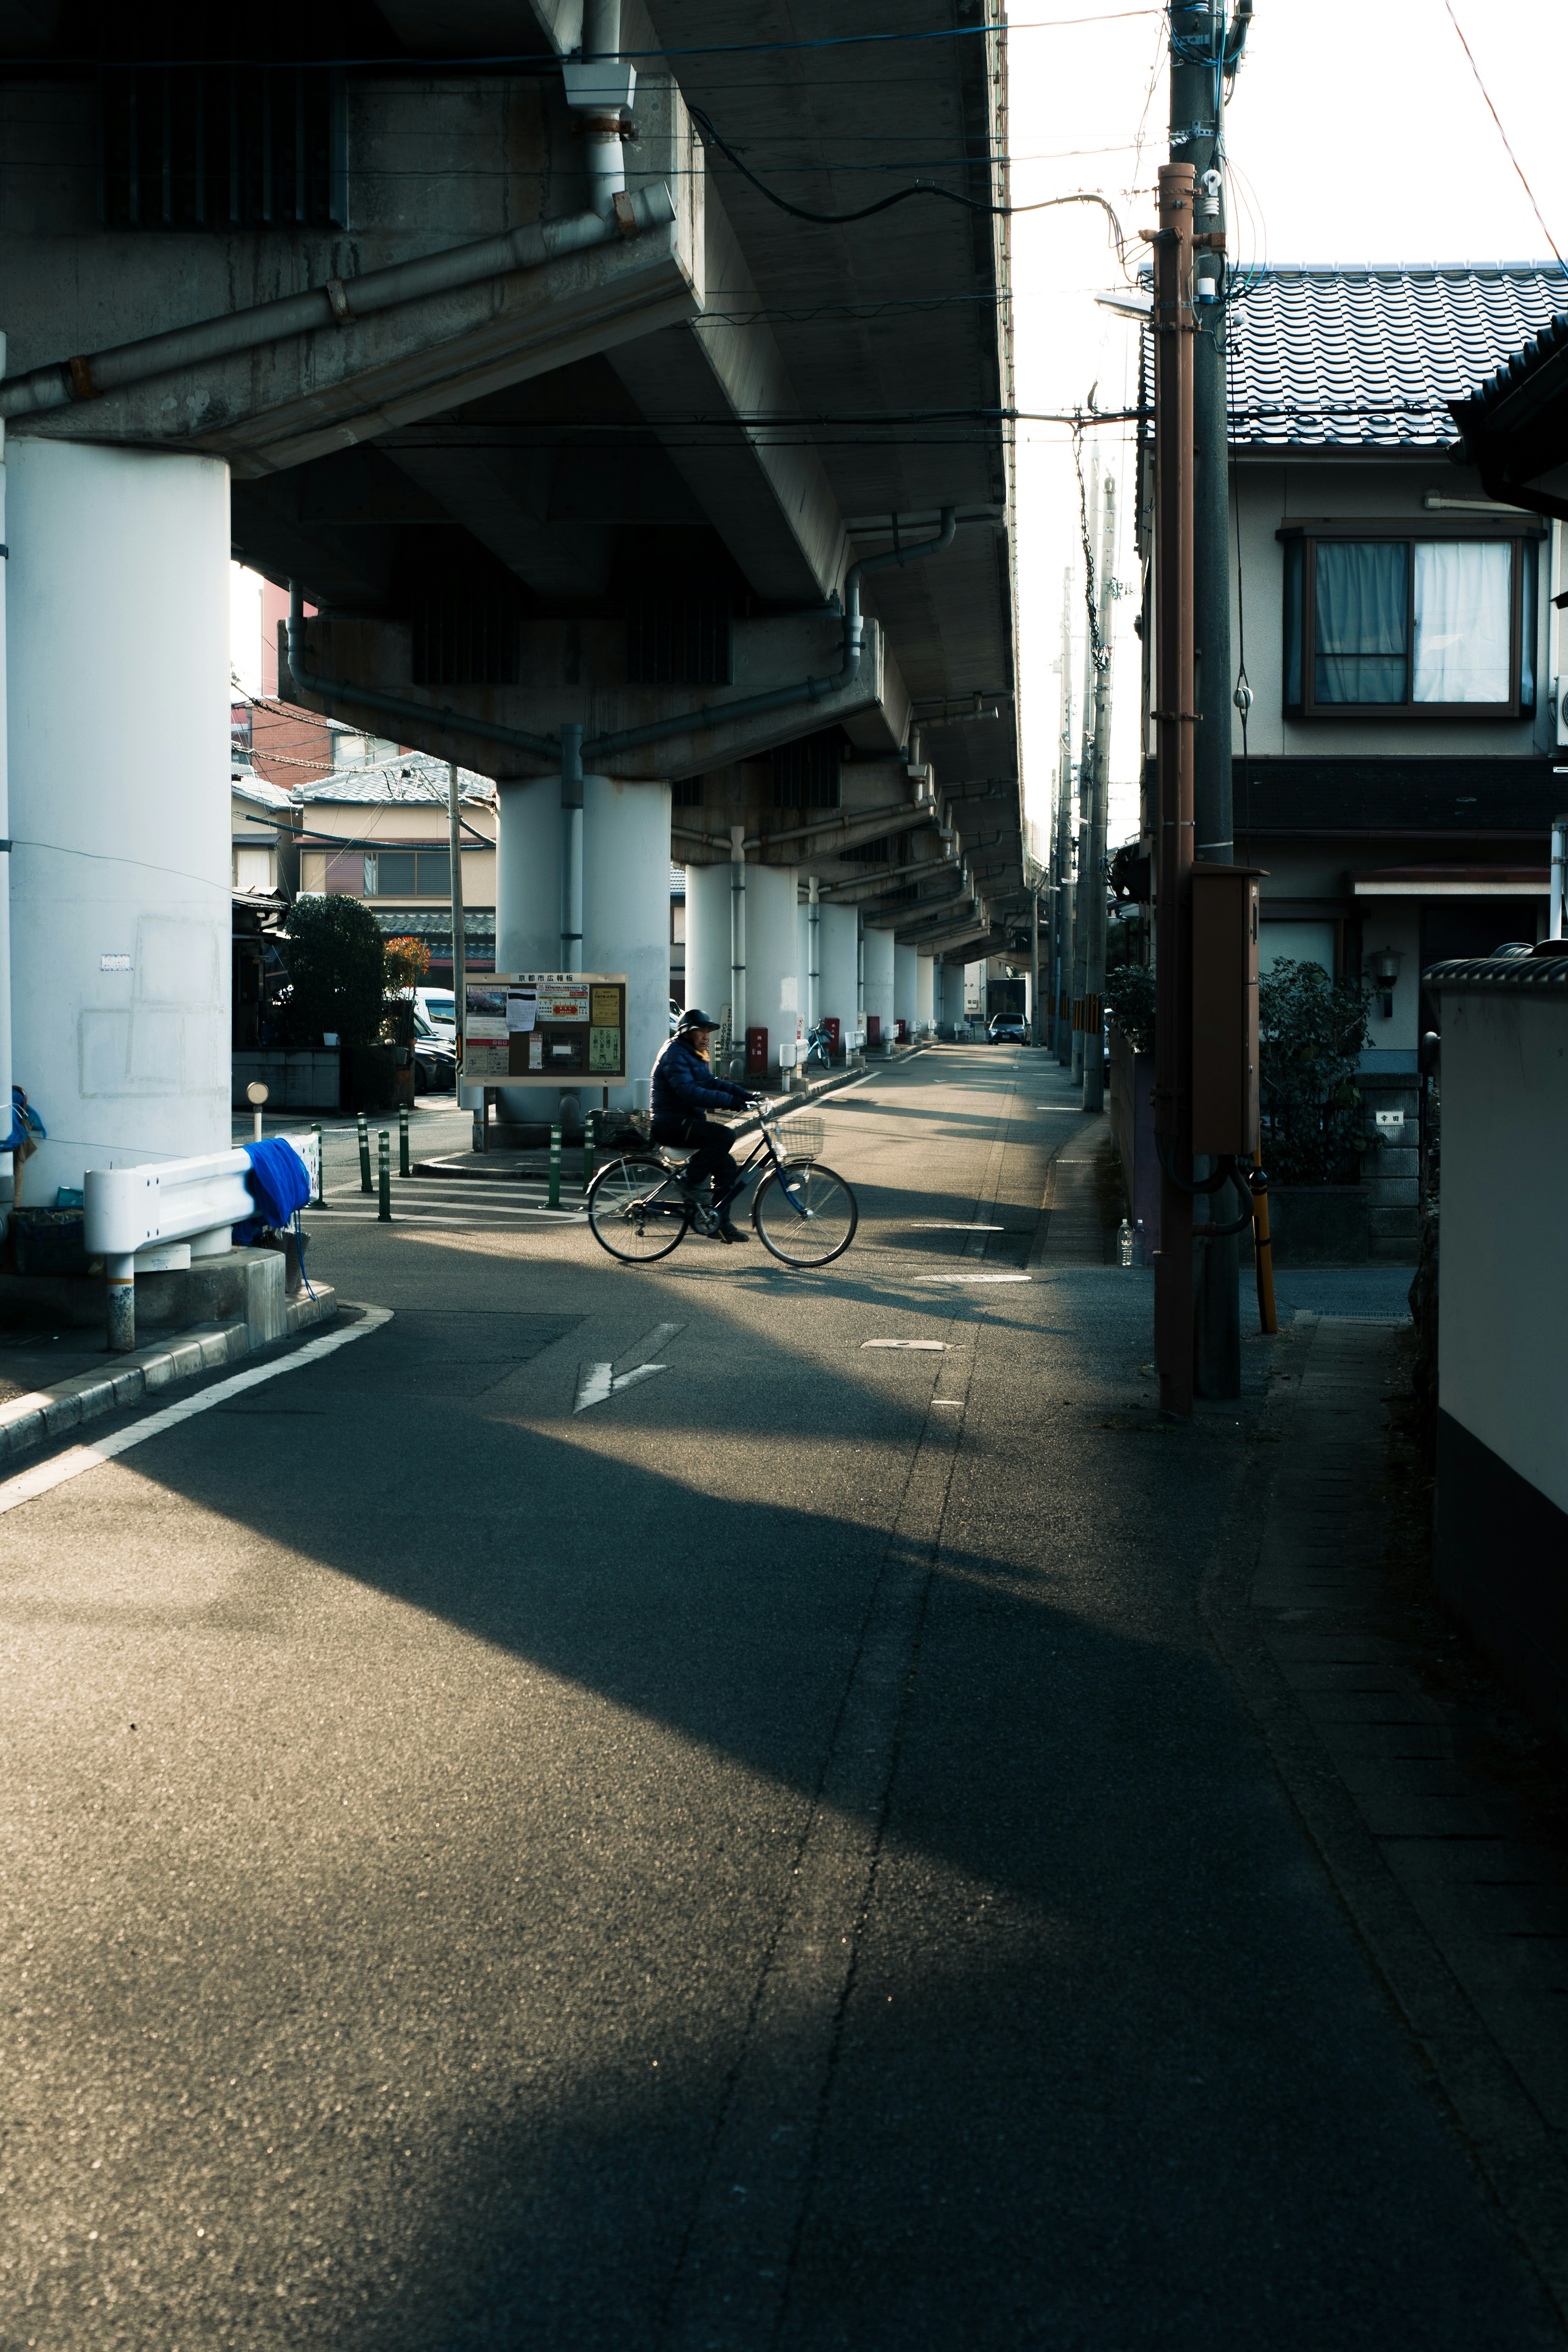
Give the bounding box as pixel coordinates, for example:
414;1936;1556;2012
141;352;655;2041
1152;162;1196;1421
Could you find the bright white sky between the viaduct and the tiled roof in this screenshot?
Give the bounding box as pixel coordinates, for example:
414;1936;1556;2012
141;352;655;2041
1009;0;1568;844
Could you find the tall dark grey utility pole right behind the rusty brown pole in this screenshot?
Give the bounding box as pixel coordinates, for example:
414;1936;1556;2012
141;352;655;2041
1171;0;1253;1397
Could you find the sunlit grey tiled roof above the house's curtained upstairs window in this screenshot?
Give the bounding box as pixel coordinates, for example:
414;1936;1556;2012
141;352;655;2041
1143;261;1568;449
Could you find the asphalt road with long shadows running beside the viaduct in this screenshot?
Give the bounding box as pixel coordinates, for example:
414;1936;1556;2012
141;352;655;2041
0;1049;1561;2352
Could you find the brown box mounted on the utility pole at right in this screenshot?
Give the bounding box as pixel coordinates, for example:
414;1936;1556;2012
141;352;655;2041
1192;866;1263;1155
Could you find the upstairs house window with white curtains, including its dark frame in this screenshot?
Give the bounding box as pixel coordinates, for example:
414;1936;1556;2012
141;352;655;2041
1281;524;1537;720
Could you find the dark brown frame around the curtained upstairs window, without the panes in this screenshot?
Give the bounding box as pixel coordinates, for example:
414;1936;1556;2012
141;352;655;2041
1274;515;1547;724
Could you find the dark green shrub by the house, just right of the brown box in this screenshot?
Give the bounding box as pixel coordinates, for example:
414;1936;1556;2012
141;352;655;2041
1258;955;1373;1183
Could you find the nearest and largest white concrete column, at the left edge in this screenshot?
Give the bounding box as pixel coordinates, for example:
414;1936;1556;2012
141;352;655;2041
0;437;233;1204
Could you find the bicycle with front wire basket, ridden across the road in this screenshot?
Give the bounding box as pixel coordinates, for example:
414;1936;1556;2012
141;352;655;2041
588;1096;860;1265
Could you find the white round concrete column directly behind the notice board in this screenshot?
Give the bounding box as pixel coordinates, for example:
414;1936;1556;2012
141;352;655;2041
496;776;668;1124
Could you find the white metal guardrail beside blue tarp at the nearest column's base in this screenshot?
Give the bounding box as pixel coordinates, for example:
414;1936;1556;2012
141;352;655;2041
82;1136;317;1352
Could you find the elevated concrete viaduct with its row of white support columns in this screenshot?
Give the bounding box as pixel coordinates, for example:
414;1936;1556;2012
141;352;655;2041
0;0;1027;1181
